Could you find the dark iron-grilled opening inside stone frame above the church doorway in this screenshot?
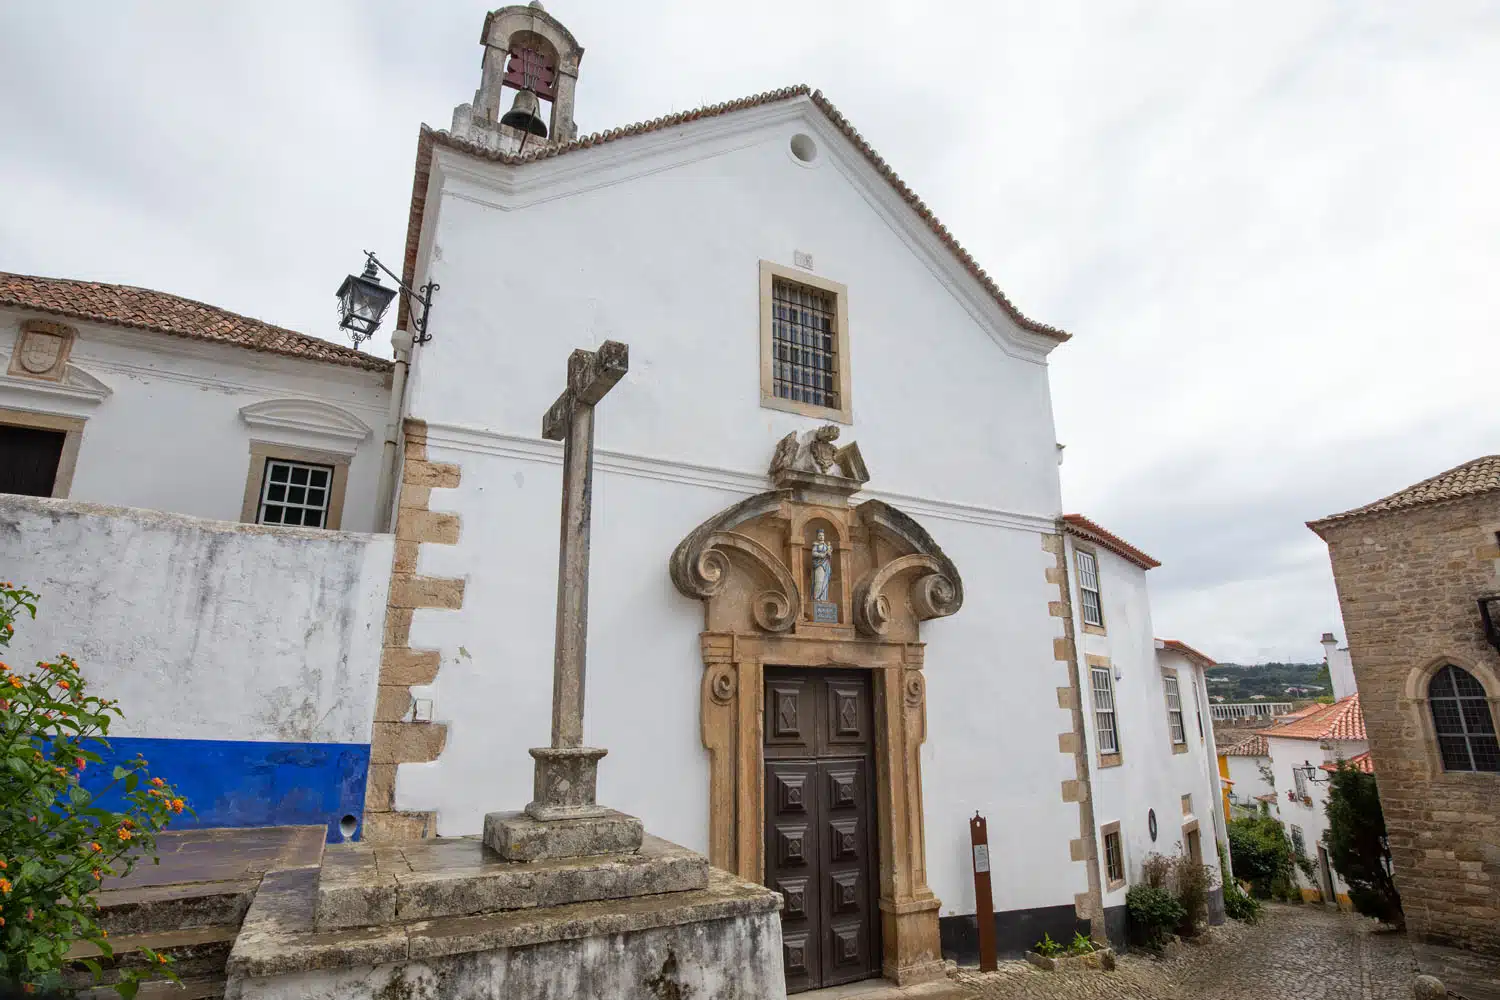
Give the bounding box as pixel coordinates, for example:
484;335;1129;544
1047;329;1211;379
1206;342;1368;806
771;277;842;409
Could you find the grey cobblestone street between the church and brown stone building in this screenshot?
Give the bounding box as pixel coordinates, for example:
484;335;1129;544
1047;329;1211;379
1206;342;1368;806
956;904;1416;1000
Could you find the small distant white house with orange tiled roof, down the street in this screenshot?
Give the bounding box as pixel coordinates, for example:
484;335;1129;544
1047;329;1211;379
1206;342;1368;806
1260;694;1374;909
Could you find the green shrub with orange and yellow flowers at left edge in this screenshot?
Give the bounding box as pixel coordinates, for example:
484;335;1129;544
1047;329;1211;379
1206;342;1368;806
0;583;186;1000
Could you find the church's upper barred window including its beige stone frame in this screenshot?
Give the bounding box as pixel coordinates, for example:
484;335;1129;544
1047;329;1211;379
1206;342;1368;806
761;261;854;423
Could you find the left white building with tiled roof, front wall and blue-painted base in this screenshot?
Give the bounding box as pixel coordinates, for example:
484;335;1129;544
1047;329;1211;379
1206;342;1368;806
0;273;395;840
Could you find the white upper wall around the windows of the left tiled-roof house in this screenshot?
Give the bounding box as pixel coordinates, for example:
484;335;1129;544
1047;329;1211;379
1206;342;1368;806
0;310;389;531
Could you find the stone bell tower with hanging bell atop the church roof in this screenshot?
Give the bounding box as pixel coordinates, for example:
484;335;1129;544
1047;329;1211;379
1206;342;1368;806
453;0;584;153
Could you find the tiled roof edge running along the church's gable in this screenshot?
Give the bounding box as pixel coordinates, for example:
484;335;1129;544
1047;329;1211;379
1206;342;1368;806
401;84;1073;342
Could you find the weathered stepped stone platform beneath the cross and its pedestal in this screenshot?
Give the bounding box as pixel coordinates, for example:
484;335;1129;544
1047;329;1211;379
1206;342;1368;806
225;838;785;1000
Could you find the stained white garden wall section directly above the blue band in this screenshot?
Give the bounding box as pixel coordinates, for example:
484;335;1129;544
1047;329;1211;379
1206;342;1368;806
0;495;393;744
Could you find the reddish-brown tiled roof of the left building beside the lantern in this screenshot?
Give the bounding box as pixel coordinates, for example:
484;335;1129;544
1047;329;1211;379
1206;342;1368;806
0;271;392;372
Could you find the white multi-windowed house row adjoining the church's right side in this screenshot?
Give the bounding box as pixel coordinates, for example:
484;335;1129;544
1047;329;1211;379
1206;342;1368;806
1062;514;1224;940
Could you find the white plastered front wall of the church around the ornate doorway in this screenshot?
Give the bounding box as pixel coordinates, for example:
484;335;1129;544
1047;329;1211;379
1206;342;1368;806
396;102;1085;913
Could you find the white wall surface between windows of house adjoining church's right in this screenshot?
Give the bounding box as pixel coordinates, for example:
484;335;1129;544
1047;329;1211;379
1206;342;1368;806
1067;535;1223;907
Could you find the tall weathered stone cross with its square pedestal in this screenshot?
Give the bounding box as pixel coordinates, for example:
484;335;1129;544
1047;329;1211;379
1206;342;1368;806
485;340;642;861
